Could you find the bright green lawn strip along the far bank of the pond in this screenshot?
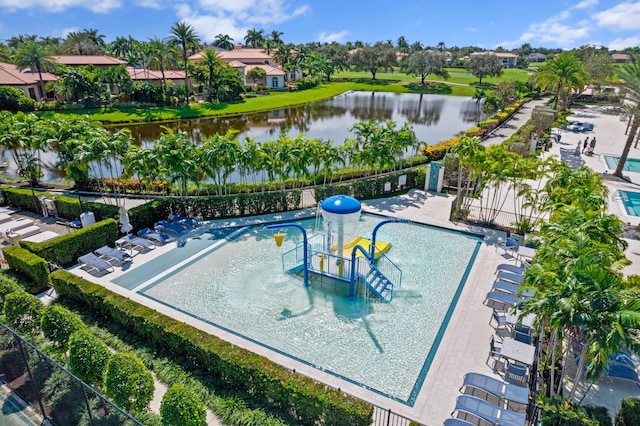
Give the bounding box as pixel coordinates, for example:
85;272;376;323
50;68;529;124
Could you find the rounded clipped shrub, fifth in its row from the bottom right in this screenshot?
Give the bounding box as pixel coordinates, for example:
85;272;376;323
4;291;44;337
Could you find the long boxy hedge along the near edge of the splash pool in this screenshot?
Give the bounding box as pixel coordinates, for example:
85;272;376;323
51;270;373;426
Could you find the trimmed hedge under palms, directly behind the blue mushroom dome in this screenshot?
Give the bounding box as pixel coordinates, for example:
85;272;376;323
314;167;426;201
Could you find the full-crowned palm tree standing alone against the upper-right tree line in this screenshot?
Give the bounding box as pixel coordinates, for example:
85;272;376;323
534;53;587;109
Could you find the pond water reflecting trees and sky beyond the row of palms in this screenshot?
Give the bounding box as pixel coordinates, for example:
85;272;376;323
115;92;480;147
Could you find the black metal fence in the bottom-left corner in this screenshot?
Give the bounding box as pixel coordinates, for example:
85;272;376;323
0;323;142;426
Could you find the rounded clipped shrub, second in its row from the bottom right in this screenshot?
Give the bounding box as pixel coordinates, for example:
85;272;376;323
104;352;154;413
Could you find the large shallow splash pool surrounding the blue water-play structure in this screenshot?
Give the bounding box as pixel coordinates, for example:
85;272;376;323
114;215;481;405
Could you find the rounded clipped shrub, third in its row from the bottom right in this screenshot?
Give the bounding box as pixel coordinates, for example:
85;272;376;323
69;329;111;385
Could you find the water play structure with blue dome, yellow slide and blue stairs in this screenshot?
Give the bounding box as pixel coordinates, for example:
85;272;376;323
268;195;409;302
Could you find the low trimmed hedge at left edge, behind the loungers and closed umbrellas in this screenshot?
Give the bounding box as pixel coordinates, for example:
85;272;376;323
0;186;119;221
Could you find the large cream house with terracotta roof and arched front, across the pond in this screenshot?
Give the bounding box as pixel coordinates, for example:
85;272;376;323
189;44;286;89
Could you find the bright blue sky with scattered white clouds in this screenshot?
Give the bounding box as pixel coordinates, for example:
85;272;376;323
0;0;640;50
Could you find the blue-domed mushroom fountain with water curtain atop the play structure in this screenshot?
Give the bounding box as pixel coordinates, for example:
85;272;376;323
320;195;362;256
